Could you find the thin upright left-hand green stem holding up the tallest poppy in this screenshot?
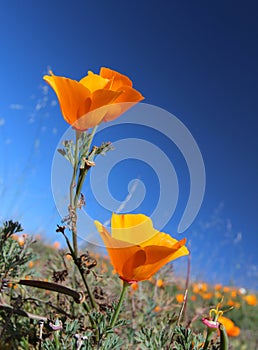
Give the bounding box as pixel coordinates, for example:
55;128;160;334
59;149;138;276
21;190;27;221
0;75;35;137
69;131;80;258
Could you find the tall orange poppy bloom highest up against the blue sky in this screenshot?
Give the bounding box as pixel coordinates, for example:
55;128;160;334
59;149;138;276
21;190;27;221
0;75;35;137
43;67;143;131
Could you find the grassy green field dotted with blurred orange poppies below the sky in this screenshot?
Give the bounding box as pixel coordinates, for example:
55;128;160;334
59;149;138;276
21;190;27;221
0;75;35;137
0;222;258;350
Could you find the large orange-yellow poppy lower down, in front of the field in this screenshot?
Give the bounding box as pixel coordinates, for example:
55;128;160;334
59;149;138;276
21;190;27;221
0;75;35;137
95;214;189;283
